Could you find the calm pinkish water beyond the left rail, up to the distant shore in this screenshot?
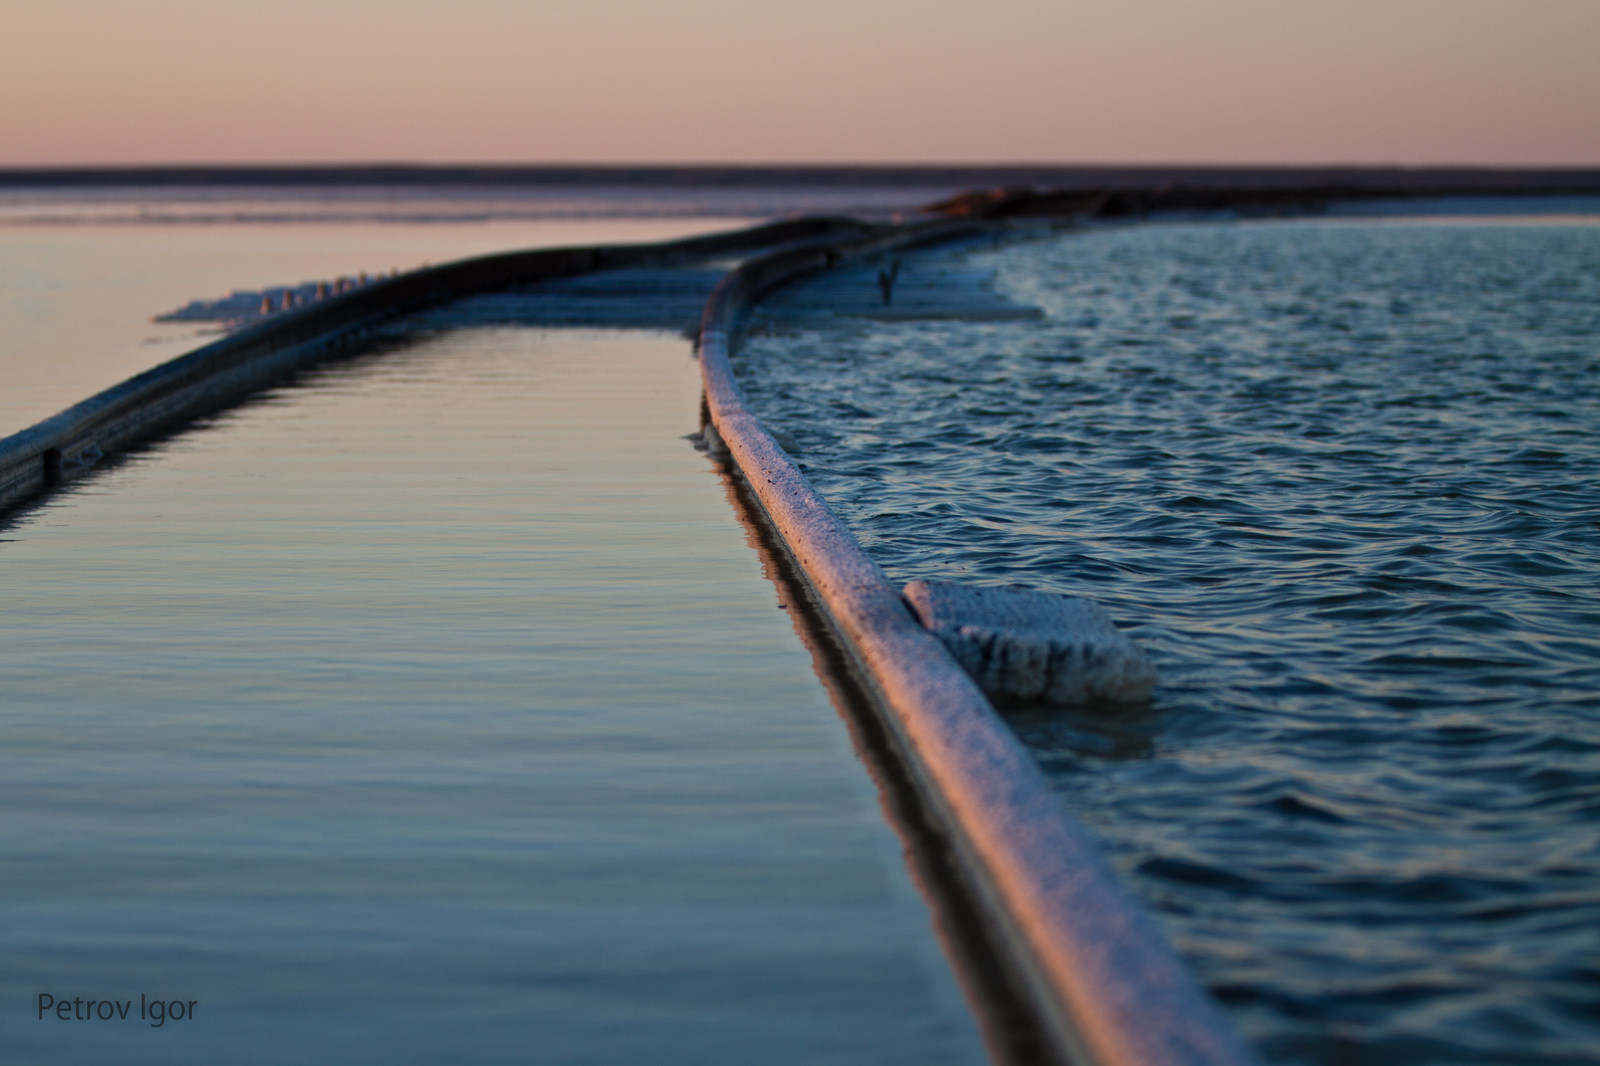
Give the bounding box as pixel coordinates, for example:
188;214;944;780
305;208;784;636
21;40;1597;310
0;186;954;437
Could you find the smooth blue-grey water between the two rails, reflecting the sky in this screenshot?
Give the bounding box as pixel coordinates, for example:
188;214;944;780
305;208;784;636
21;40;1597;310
0;330;982;1066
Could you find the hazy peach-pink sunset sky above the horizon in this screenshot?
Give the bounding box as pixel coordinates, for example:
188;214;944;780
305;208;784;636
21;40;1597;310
0;0;1600;166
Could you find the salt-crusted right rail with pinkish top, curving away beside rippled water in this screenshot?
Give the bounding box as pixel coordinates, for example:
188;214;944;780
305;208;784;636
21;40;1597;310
699;222;1253;1066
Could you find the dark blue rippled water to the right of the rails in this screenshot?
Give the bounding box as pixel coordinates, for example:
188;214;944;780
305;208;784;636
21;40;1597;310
739;219;1600;1063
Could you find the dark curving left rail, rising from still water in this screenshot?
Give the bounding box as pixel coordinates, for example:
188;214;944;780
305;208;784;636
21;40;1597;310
0;218;874;512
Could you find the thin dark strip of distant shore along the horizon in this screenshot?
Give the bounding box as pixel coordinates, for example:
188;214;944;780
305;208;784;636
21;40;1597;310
0;165;1600;197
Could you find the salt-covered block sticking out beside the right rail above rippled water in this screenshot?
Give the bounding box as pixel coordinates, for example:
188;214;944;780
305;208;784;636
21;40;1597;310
902;581;1155;704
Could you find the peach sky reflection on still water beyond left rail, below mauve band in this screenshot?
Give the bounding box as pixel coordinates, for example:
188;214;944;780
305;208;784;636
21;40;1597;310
0;211;749;437
